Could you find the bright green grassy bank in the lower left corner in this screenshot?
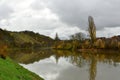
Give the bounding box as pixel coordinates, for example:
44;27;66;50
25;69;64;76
0;58;43;80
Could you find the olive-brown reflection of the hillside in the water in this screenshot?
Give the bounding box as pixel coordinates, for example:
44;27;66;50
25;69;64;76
9;49;53;64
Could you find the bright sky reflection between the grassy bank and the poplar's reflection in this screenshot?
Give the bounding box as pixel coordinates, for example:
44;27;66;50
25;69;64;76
21;56;89;80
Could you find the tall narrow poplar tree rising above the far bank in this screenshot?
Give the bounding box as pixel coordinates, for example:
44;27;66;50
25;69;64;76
88;16;96;44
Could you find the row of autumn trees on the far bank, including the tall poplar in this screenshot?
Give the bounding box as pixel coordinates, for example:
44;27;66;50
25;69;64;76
53;16;120;50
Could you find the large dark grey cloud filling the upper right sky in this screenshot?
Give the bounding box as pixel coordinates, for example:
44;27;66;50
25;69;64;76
40;0;120;29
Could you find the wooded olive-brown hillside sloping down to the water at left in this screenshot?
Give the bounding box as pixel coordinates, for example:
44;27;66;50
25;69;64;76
0;29;53;48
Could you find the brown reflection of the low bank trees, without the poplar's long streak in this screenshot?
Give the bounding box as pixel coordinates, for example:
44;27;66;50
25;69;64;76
53;50;120;67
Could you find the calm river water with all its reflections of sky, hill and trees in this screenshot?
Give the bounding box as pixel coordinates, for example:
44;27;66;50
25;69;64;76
8;50;120;80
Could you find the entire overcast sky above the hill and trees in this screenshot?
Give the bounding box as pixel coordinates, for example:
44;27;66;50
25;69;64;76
0;0;120;38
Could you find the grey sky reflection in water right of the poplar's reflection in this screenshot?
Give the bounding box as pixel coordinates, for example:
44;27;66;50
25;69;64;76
96;63;120;80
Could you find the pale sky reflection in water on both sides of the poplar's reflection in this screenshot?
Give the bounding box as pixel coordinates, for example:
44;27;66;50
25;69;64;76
21;56;120;80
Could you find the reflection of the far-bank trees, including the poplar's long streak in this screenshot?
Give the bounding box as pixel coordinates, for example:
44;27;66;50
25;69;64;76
54;50;120;80
